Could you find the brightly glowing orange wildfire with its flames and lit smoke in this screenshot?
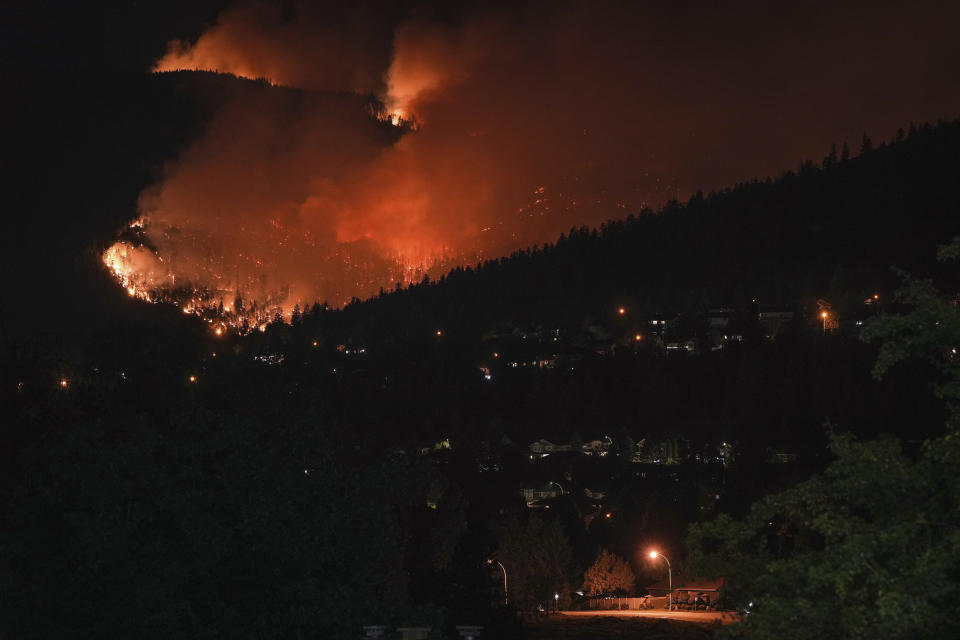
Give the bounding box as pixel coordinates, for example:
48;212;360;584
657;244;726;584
110;8;684;336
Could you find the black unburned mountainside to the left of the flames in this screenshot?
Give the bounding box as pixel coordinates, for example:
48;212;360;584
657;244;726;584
0;72;396;335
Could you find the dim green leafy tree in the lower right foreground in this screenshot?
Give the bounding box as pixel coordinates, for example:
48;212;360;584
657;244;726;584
689;241;960;640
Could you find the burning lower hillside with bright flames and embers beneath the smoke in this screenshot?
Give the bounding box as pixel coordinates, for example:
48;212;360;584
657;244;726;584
102;200;476;337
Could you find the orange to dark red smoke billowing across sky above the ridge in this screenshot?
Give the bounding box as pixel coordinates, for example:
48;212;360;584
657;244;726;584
105;2;960;316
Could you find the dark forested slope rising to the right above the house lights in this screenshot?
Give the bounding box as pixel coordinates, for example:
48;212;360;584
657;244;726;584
326;121;960;335
